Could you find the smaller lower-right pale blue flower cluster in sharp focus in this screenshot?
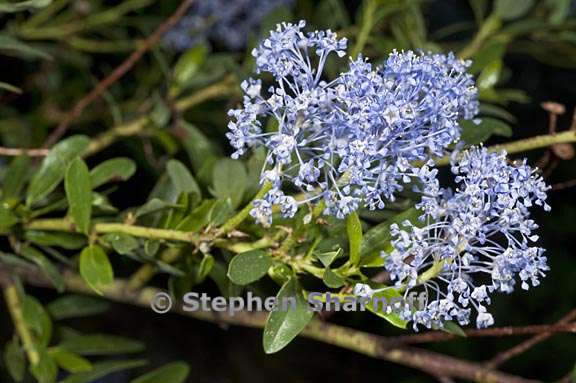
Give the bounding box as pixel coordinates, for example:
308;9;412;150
382;148;550;328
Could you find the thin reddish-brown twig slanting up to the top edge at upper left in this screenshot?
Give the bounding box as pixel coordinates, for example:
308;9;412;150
42;0;194;148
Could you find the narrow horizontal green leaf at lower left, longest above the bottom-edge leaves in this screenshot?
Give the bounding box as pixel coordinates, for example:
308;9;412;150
58;334;145;356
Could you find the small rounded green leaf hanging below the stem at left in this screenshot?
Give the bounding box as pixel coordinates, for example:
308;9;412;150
80;245;114;294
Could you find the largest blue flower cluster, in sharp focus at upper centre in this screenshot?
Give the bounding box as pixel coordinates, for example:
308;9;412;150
227;21;478;225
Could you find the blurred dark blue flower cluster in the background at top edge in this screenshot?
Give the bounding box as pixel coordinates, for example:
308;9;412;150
164;0;294;51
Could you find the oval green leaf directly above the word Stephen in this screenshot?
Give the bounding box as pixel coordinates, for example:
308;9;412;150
227;250;272;285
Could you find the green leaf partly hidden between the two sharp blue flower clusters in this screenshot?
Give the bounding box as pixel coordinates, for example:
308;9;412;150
360;208;422;266
